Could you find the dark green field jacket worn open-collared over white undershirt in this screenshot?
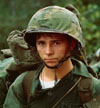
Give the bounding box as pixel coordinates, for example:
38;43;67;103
3;60;100;108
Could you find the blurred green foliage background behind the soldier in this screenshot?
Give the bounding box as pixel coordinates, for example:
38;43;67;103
0;0;100;54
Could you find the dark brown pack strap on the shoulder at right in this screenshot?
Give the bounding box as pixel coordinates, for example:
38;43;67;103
78;75;93;104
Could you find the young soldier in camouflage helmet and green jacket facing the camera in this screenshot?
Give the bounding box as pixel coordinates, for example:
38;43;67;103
4;6;100;108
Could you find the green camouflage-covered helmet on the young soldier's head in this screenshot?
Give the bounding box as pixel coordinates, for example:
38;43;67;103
24;6;84;47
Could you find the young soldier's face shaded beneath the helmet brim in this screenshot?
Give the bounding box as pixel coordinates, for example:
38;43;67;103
36;34;70;67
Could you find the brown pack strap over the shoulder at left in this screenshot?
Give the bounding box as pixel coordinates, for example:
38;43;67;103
23;71;35;103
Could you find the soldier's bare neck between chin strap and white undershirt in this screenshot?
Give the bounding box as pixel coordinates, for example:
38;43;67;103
41;58;73;81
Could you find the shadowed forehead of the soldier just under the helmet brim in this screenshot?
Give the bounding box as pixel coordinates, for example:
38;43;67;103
36;33;67;40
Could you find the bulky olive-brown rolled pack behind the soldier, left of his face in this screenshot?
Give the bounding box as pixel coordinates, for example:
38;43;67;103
7;30;39;65
